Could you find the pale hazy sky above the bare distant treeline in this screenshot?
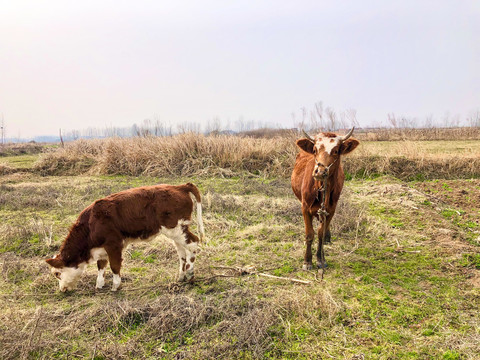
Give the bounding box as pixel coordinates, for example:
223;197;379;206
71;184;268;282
0;0;480;138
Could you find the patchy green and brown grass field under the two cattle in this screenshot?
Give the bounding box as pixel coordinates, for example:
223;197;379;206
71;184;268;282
0;141;480;359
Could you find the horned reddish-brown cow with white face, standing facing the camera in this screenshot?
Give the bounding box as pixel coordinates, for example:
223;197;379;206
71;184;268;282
291;128;359;270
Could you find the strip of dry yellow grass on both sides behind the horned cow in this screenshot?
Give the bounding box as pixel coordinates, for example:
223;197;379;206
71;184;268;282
34;134;480;179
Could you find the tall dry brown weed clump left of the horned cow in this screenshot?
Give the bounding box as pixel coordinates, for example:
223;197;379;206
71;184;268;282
35;133;296;176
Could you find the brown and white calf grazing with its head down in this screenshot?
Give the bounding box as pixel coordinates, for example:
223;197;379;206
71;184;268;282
46;183;204;291
